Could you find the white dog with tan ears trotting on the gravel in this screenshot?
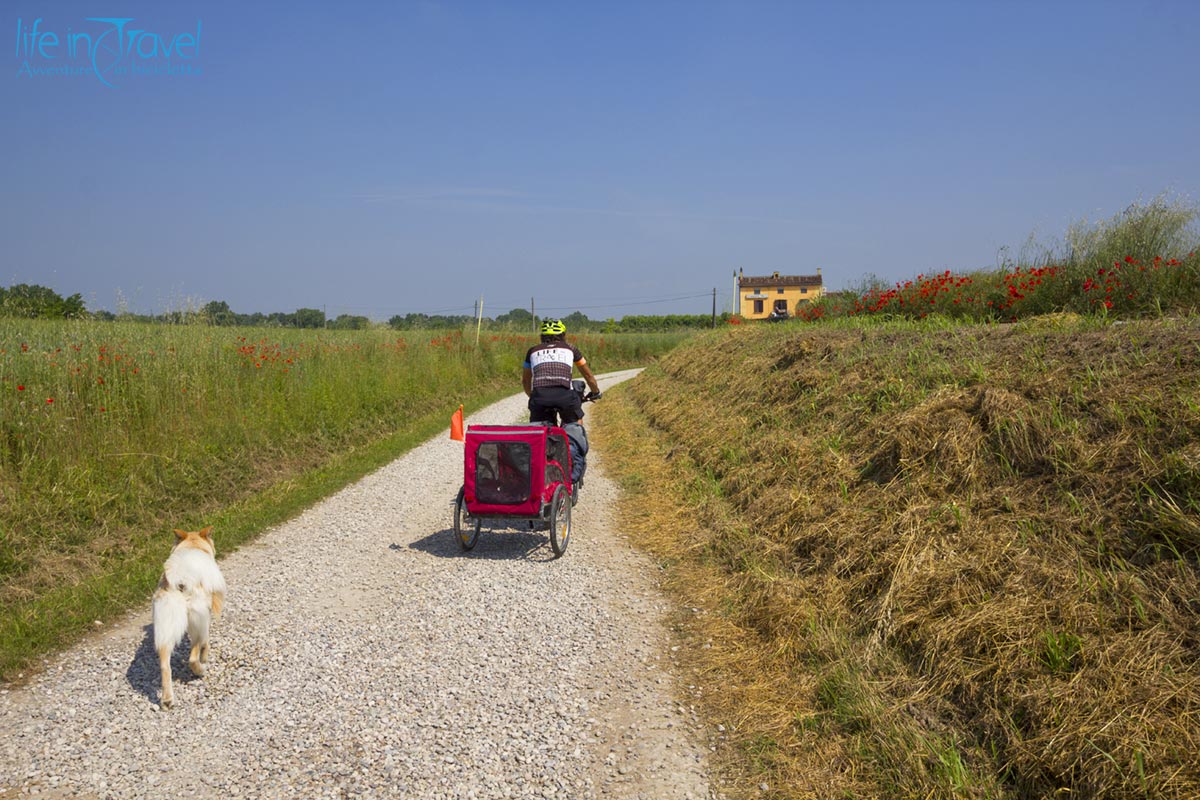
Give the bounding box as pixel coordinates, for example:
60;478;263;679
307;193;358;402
154;527;226;709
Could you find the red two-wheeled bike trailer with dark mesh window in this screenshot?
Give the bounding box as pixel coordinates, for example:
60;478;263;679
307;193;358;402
454;425;574;557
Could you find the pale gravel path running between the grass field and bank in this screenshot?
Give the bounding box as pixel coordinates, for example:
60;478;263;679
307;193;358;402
0;372;714;800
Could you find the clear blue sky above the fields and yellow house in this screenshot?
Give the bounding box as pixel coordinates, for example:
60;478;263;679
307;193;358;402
0;0;1200;319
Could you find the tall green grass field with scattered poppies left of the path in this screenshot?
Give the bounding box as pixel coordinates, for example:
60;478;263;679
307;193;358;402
0;318;683;676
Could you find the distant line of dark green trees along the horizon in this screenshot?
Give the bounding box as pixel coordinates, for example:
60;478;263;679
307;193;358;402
0;283;730;333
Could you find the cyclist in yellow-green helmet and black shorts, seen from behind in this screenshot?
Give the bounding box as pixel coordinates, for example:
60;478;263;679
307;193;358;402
521;319;600;426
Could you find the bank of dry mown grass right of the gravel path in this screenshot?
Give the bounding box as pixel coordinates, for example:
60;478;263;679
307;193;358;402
594;315;1200;798
